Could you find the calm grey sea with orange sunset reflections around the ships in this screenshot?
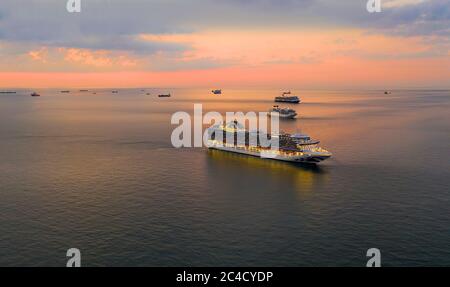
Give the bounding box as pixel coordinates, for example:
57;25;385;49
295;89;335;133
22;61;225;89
0;89;450;266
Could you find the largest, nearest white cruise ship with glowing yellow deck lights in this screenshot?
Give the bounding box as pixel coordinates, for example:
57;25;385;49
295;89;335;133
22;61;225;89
208;121;331;164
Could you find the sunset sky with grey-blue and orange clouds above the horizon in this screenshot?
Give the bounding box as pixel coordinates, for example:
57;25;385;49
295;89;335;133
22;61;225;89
0;0;450;88
